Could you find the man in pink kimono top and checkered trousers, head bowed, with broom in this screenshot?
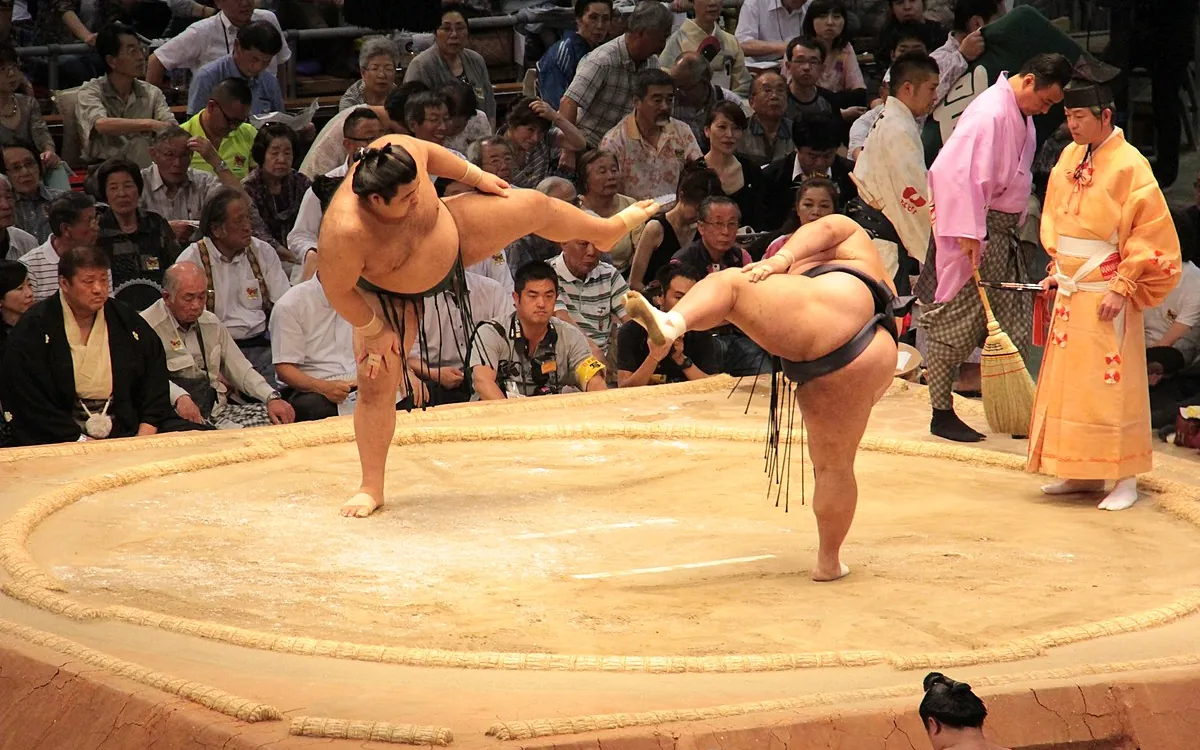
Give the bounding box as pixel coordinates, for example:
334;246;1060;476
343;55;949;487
917;54;1072;443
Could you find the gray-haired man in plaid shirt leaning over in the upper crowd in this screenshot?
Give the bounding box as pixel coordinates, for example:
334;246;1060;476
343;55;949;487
559;0;674;146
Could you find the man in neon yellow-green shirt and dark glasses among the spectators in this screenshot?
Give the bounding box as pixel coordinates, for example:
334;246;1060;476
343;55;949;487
184;78;258;180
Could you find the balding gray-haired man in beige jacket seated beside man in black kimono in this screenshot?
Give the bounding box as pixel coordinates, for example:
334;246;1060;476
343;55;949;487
142;263;295;430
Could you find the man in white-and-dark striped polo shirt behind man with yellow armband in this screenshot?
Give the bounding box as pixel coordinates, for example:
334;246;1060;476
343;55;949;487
550;234;629;362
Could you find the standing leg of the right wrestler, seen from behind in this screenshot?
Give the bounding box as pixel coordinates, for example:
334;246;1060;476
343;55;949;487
797;330;896;581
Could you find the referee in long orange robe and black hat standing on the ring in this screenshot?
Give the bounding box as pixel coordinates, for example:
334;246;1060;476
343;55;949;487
1027;58;1181;510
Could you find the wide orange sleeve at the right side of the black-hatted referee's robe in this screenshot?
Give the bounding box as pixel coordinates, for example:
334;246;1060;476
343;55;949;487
1109;176;1181;310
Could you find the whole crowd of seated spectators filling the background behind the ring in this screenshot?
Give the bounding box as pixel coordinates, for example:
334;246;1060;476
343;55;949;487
0;0;1200;444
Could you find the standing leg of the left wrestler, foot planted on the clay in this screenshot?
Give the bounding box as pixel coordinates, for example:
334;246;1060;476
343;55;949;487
342;294;420;518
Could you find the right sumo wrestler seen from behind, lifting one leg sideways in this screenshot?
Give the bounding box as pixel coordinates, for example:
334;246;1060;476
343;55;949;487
625;214;898;581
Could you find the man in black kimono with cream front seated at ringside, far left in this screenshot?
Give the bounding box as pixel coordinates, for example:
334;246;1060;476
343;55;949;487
0;247;201;445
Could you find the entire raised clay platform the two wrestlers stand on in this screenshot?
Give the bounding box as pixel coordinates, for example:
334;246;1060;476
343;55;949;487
0;377;1200;750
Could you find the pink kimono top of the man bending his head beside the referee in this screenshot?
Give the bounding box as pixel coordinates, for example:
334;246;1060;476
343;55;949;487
929;72;1037;302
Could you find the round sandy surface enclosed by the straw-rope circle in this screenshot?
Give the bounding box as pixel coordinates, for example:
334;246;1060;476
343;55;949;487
31;432;1200;655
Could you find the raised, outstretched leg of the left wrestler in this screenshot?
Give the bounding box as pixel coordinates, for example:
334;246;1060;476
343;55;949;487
443;190;659;265
